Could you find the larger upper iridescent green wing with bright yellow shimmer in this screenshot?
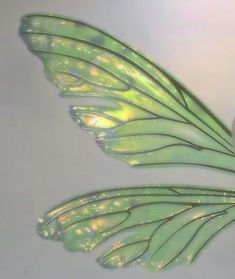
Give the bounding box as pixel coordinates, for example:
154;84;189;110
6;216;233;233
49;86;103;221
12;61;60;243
20;14;235;172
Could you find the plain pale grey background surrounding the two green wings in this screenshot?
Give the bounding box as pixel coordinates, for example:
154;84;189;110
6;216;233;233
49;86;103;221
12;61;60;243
0;0;235;279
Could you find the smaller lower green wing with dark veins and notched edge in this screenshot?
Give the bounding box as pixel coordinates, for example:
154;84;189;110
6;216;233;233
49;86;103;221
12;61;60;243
38;186;235;271
